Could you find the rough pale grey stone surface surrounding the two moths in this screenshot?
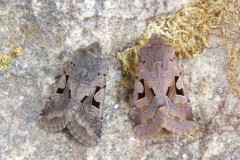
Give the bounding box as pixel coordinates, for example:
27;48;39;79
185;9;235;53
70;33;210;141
0;0;240;160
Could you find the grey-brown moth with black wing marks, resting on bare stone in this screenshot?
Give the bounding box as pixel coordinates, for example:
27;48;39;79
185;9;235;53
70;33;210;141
38;43;106;146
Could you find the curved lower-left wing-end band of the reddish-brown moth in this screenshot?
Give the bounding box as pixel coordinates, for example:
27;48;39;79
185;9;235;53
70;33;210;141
134;107;167;139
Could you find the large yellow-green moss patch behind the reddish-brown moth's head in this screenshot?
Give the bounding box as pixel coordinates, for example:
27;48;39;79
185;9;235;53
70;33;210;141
117;0;240;95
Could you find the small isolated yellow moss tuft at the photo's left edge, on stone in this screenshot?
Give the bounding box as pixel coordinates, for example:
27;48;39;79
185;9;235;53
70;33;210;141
0;47;24;70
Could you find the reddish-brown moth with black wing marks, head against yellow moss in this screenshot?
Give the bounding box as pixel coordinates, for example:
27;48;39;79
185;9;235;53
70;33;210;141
133;33;197;139
